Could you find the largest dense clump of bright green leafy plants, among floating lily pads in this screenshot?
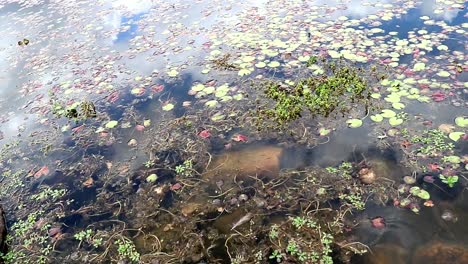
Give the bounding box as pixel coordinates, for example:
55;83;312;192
257;57;371;126
